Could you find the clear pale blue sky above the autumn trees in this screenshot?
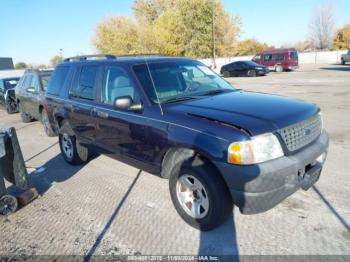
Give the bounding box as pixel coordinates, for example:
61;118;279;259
0;0;350;64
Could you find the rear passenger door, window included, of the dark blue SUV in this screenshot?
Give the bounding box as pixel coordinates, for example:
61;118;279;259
64;65;100;146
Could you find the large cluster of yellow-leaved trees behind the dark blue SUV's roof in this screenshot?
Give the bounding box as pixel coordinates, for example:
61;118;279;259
92;0;240;58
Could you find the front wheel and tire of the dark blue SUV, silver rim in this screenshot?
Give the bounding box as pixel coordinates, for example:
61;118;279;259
169;157;233;231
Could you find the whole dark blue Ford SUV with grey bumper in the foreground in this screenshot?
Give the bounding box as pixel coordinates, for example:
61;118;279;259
46;55;329;230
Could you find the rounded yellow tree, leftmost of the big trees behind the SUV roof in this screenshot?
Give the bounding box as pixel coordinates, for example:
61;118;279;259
92;16;139;55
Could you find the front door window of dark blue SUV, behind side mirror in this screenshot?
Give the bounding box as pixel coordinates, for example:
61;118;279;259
101;67;135;105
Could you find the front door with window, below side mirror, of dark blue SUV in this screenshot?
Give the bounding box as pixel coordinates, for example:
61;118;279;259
95;66;154;164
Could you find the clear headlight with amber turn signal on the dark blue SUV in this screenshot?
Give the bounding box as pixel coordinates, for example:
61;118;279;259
227;133;283;165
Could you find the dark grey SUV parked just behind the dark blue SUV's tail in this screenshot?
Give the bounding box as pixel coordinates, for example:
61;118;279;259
15;69;54;136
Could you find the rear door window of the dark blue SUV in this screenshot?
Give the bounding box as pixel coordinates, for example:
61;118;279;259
70;66;98;100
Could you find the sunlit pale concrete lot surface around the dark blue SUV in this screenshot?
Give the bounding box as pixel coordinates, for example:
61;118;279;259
0;65;350;256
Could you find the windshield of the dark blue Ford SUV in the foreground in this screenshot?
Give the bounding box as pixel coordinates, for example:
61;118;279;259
133;61;234;103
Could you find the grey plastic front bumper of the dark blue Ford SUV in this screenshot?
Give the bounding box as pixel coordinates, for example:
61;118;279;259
214;131;329;214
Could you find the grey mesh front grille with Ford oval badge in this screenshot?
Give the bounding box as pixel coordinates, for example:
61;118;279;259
278;114;322;151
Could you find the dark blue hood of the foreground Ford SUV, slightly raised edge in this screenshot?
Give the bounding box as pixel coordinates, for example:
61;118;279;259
169;91;318;135
